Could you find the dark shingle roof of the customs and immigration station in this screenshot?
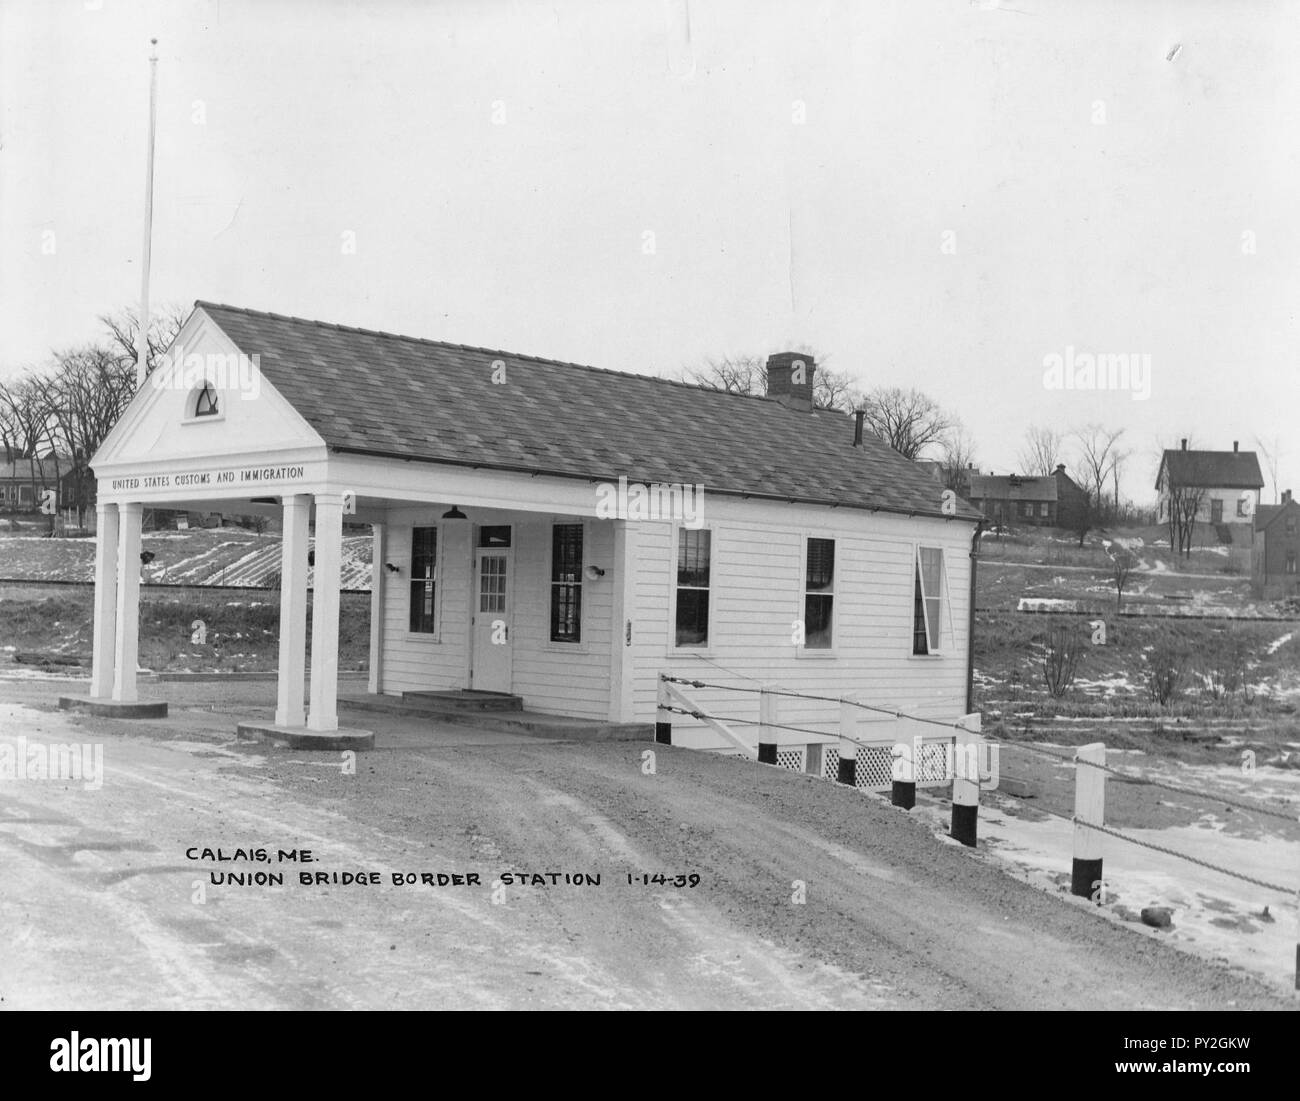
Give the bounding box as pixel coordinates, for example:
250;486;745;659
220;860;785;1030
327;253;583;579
195;302;980;520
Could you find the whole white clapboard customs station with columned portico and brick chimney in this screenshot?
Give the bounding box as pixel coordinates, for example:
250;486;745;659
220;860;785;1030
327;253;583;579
81;302;980;745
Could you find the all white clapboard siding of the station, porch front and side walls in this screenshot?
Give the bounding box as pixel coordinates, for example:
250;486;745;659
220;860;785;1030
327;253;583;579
382;499;971;745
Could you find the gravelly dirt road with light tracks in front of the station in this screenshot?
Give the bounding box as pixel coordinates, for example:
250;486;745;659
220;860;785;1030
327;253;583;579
0;682;1291;1009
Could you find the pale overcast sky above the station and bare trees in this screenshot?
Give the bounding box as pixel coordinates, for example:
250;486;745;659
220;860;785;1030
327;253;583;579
0;0;1300;500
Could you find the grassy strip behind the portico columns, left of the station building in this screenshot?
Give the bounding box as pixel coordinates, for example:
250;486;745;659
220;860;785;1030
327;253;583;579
0;585;371;672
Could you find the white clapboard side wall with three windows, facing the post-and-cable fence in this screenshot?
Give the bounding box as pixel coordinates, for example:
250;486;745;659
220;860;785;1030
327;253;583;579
633;502;972;746
